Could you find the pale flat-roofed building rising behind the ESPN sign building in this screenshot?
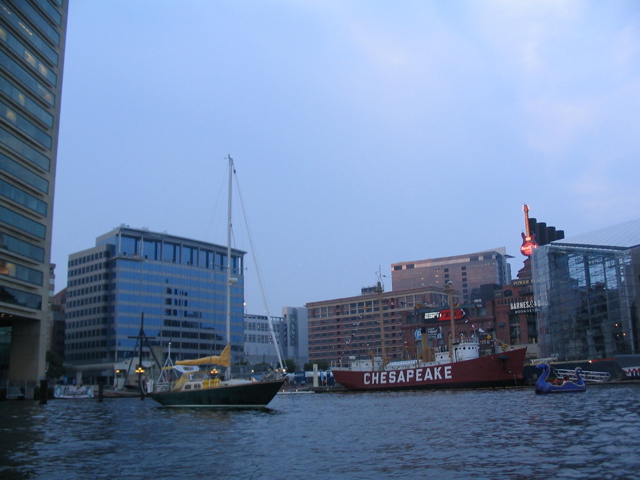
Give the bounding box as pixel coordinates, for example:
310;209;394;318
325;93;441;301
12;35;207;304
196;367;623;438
391;247;511;303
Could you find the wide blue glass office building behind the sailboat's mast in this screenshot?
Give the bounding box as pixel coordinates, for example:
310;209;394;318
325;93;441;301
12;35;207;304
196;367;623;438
65;226;245;376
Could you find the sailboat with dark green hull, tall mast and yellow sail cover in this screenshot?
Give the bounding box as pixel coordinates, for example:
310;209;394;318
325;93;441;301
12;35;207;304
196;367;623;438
149;156;286;408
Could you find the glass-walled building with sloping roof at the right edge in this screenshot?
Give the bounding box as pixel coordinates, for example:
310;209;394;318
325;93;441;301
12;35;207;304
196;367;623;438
532;219;640;360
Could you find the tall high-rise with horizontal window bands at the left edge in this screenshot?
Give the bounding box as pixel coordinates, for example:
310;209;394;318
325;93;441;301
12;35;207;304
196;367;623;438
0;0;68;390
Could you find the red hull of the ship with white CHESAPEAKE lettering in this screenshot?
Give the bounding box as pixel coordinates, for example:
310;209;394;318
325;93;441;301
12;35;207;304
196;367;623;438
332;348;527;391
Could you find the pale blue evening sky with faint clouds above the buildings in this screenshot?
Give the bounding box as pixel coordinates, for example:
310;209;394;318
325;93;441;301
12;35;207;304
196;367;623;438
52;0;640;315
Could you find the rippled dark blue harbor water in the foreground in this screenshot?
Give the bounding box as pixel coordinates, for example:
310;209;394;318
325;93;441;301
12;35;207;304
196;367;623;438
0;384;640;480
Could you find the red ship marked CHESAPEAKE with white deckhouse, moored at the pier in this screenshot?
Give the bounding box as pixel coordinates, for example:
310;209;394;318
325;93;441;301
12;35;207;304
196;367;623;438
332;340;527;391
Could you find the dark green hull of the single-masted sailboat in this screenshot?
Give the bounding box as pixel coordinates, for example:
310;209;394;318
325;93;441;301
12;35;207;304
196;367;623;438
149;380;284;408
